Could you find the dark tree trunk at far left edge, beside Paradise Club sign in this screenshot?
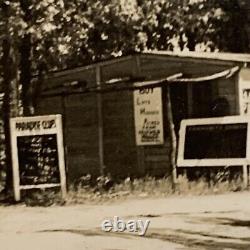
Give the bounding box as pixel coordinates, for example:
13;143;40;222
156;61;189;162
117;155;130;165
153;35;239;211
1;0;19;195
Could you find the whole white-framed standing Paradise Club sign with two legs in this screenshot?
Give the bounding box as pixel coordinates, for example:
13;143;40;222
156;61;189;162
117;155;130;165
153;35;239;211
10;115;66;201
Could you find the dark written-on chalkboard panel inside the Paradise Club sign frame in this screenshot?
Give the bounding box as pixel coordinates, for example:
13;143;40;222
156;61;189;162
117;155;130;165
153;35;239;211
17;135;60;185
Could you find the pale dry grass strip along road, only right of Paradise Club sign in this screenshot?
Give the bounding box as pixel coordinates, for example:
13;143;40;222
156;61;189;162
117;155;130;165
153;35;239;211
66;175;246;204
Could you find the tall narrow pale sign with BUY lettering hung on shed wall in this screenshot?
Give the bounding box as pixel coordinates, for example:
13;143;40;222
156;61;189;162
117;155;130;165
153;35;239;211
134;87;164;146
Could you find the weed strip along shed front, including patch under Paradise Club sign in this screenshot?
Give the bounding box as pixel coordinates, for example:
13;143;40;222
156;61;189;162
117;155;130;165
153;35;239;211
10;172;247;206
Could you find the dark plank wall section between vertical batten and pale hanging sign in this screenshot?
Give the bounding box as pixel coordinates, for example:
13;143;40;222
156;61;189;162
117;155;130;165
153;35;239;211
102;91;139;177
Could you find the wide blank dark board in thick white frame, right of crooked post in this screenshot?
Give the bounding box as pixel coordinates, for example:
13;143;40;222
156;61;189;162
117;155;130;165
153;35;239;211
177;116;250;167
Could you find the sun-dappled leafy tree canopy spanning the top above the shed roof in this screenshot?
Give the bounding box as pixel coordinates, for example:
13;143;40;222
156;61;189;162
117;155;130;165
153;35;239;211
0;0;250;73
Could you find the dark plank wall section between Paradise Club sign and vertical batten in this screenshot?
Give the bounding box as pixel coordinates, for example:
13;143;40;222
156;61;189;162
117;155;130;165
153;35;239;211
64;94;100;180
